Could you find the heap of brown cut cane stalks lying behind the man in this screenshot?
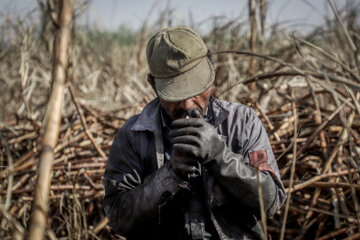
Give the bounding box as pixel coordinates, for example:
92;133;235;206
0;81;360;240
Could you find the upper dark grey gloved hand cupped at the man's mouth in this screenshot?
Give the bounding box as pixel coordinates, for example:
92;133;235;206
169;118;224;163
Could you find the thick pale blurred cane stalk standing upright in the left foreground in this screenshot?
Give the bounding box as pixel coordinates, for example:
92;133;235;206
27;0;73;240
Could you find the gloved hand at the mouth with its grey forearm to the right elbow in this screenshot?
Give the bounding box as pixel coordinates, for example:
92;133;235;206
169;110;284;218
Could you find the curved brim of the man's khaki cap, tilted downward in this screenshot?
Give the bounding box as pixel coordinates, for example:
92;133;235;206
155;57;215;102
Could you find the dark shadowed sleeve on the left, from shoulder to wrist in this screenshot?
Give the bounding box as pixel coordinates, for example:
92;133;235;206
104;123;186;236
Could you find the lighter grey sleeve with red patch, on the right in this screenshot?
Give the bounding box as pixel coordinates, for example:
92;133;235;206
209;107;286;216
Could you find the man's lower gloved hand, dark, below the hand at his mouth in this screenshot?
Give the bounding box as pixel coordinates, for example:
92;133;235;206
170;149;201;180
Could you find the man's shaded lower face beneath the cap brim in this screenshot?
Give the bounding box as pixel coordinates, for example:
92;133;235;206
159;87;212;120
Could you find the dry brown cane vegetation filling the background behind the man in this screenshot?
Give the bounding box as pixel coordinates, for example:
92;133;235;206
0;1;360;240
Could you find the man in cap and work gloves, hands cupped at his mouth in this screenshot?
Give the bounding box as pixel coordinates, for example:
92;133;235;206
104;27;286;239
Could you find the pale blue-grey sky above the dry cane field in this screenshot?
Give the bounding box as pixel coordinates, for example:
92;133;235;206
0;0;345;31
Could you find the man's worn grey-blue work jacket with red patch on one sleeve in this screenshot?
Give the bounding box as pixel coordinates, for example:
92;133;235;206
104;96;286;239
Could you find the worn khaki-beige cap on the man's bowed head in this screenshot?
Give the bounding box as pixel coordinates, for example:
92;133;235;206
146;27;215;102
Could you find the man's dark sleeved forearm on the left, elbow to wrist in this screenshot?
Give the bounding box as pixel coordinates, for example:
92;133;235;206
104;162;182;236
